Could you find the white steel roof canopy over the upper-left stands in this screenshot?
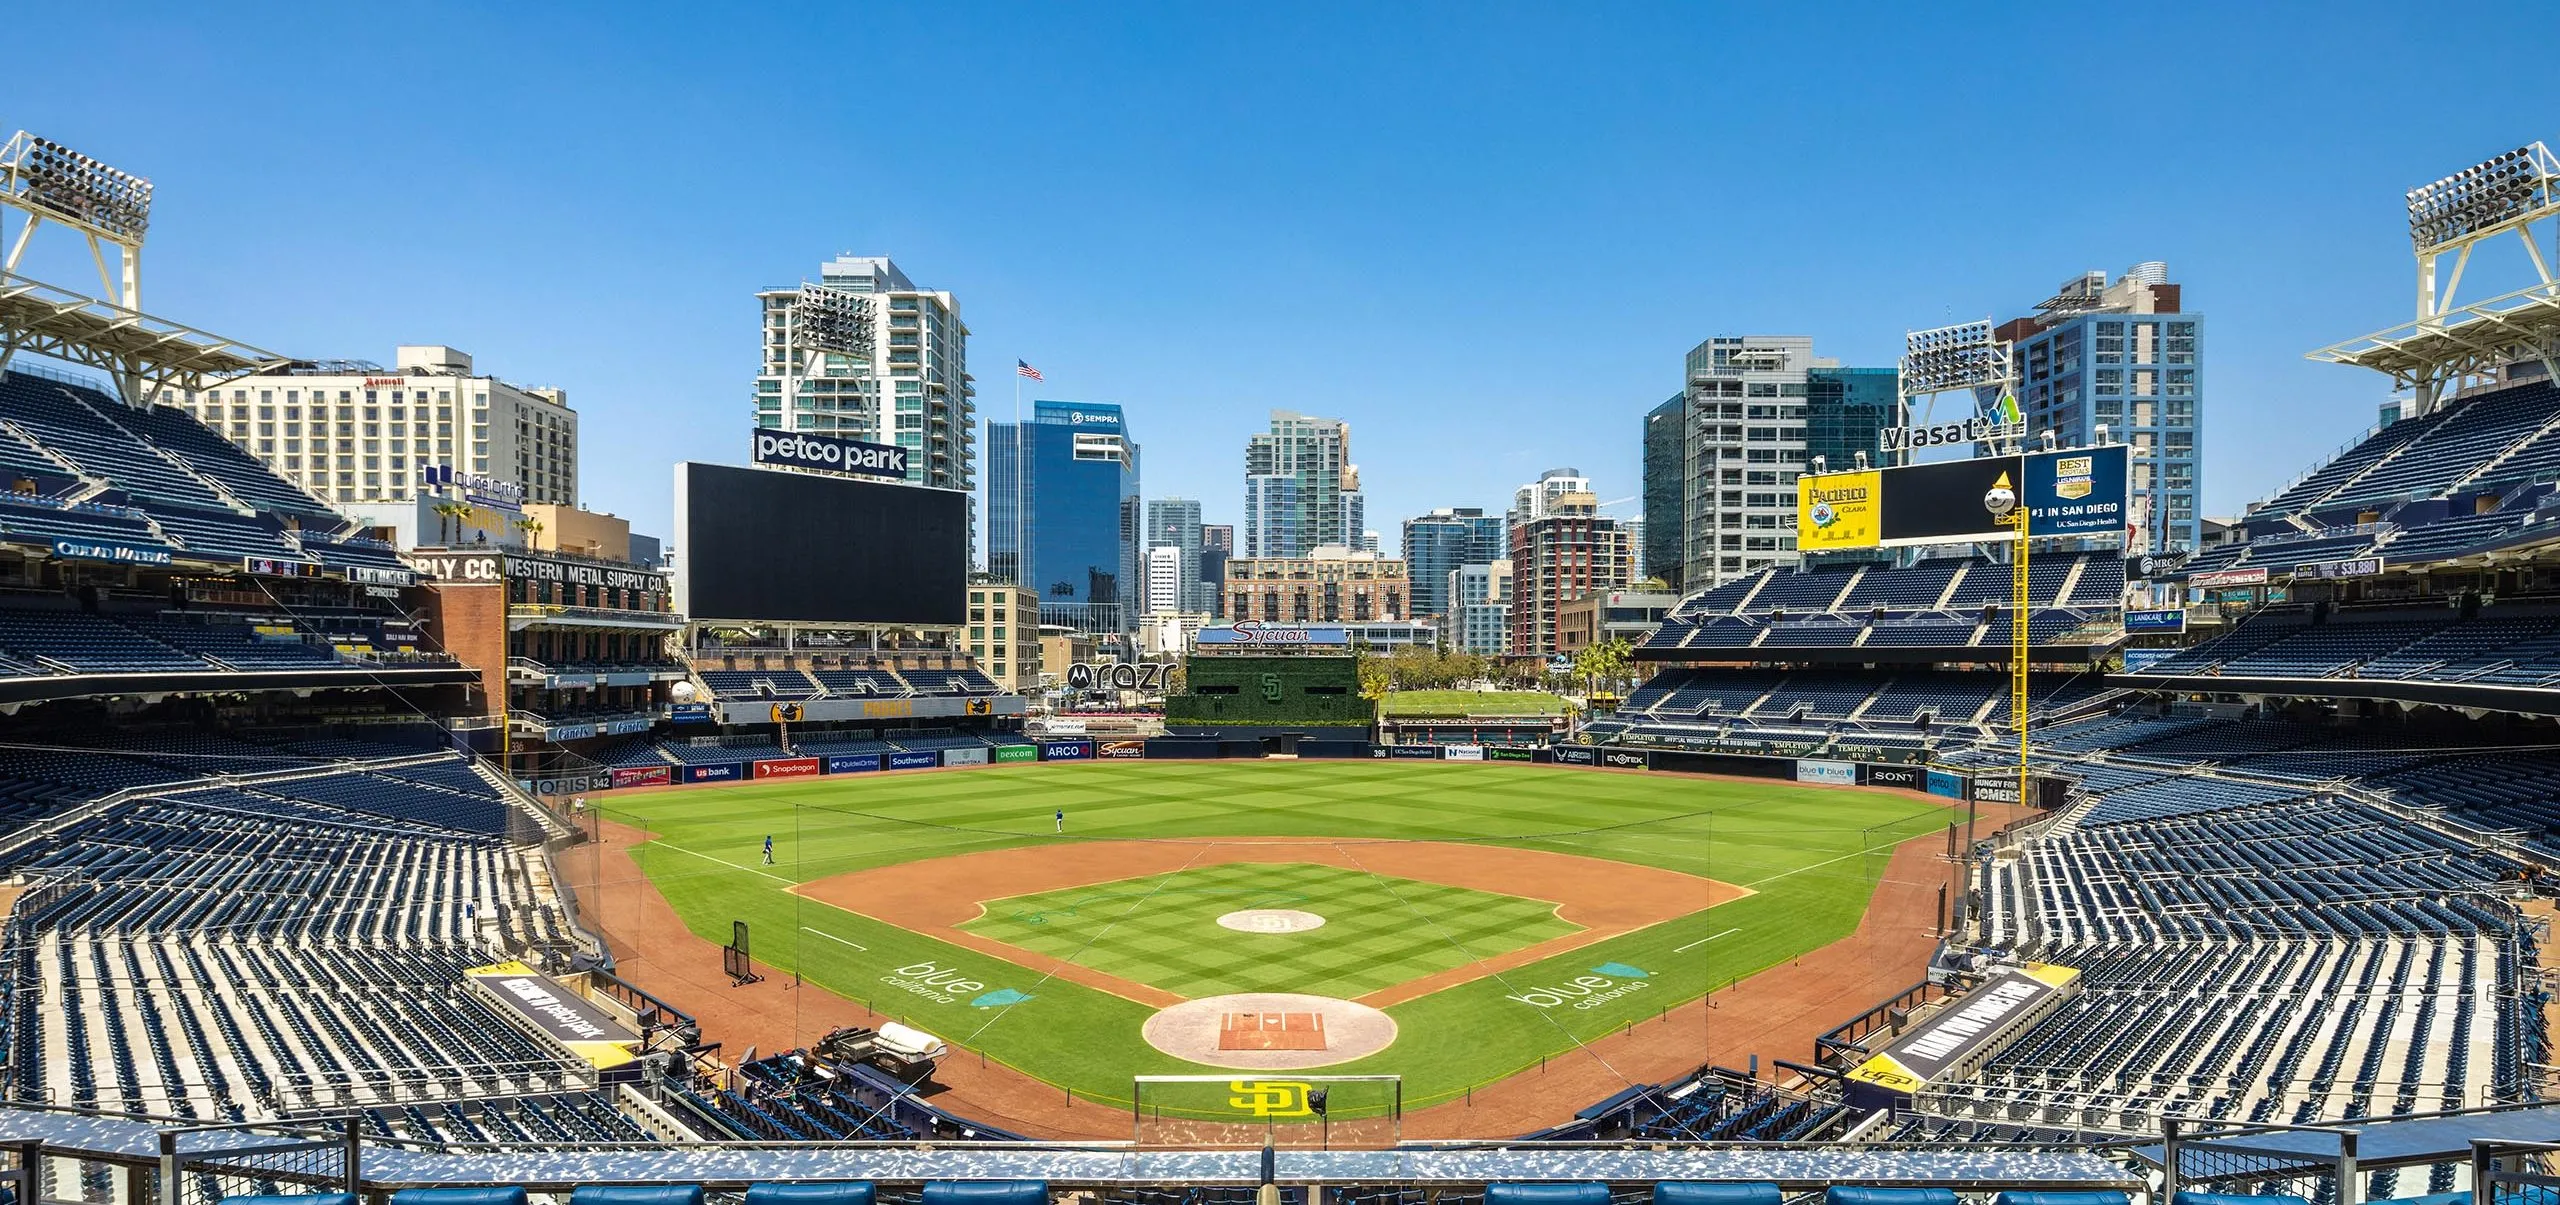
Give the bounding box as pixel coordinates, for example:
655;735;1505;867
0;274;284;404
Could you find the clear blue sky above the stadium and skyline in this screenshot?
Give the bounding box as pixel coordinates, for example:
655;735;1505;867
0;3;2560;545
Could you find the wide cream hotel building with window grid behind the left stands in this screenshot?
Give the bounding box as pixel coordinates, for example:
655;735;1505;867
172;345;579;527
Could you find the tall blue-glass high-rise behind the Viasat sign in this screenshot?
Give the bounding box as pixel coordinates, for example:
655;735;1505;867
1999;264;2204;553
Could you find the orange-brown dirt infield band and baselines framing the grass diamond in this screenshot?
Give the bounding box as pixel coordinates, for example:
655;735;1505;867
791;837;1751;1008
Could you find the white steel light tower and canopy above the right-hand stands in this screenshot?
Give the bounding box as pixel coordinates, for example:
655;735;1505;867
2309;143;2560;414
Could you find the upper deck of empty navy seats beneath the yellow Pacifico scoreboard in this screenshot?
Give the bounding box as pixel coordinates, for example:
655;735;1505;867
1638;553;2125;660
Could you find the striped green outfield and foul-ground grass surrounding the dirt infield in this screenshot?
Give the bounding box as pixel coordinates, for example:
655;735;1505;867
602;760;1951;1108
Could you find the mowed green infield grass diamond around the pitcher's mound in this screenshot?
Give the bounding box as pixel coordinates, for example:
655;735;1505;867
963;862;1580;1000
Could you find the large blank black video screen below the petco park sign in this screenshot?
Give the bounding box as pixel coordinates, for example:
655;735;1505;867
676;461;968;627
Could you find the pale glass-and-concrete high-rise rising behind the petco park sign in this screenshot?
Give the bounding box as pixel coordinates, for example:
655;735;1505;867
755;256;978;489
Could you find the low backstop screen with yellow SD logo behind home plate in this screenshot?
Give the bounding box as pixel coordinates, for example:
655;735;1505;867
1129;1072;1405;1149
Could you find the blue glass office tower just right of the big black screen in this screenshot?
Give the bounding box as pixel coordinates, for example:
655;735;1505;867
986;402;1144;637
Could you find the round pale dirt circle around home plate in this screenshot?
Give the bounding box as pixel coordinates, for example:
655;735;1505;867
1139;997;1395;1072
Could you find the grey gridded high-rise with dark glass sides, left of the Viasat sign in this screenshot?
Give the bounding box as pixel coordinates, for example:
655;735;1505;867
1644;335;1900;591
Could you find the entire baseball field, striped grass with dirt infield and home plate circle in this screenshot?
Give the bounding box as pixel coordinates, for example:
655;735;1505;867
602;760;1956;1108
